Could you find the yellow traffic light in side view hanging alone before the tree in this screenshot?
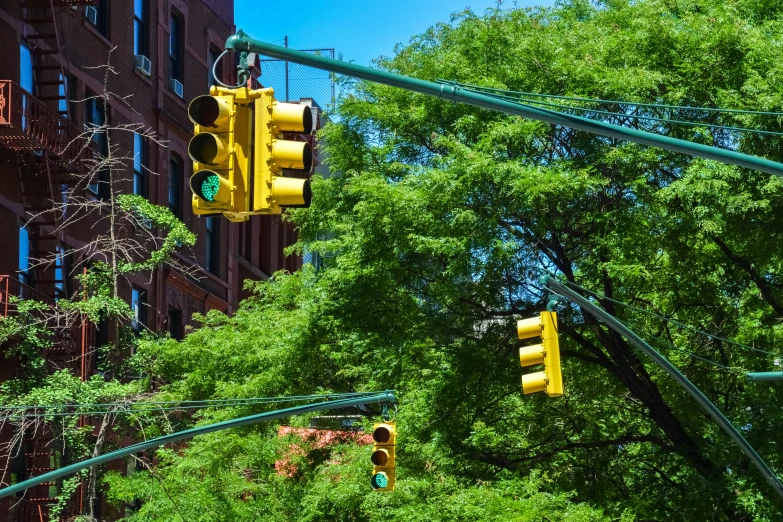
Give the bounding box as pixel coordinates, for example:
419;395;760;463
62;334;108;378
517;312;563;397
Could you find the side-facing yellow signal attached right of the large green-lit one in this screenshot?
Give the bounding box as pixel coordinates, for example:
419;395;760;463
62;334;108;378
253;89;313;214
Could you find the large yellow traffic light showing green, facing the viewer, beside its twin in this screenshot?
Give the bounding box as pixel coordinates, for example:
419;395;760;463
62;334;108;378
188;87;252;221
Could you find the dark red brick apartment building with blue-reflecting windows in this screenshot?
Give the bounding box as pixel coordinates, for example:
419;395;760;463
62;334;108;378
0;0;321;521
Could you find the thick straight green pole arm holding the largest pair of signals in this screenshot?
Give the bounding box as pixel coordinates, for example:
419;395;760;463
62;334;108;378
226;30;783;176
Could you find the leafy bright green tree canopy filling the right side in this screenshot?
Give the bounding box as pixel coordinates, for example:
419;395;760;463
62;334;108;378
102;0;783;521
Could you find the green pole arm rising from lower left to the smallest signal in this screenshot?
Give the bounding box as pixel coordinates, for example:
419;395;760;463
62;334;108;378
0;390;397;498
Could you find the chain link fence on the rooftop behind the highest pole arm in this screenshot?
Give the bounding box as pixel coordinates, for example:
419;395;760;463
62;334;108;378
258;48;334;111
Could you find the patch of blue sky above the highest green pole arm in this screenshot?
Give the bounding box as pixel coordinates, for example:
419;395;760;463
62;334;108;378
234;0;554;65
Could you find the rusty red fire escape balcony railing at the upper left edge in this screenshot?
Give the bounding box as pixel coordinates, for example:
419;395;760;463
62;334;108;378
0;80;91;166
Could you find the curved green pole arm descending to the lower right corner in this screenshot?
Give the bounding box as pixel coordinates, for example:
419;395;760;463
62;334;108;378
538;275;783;499
